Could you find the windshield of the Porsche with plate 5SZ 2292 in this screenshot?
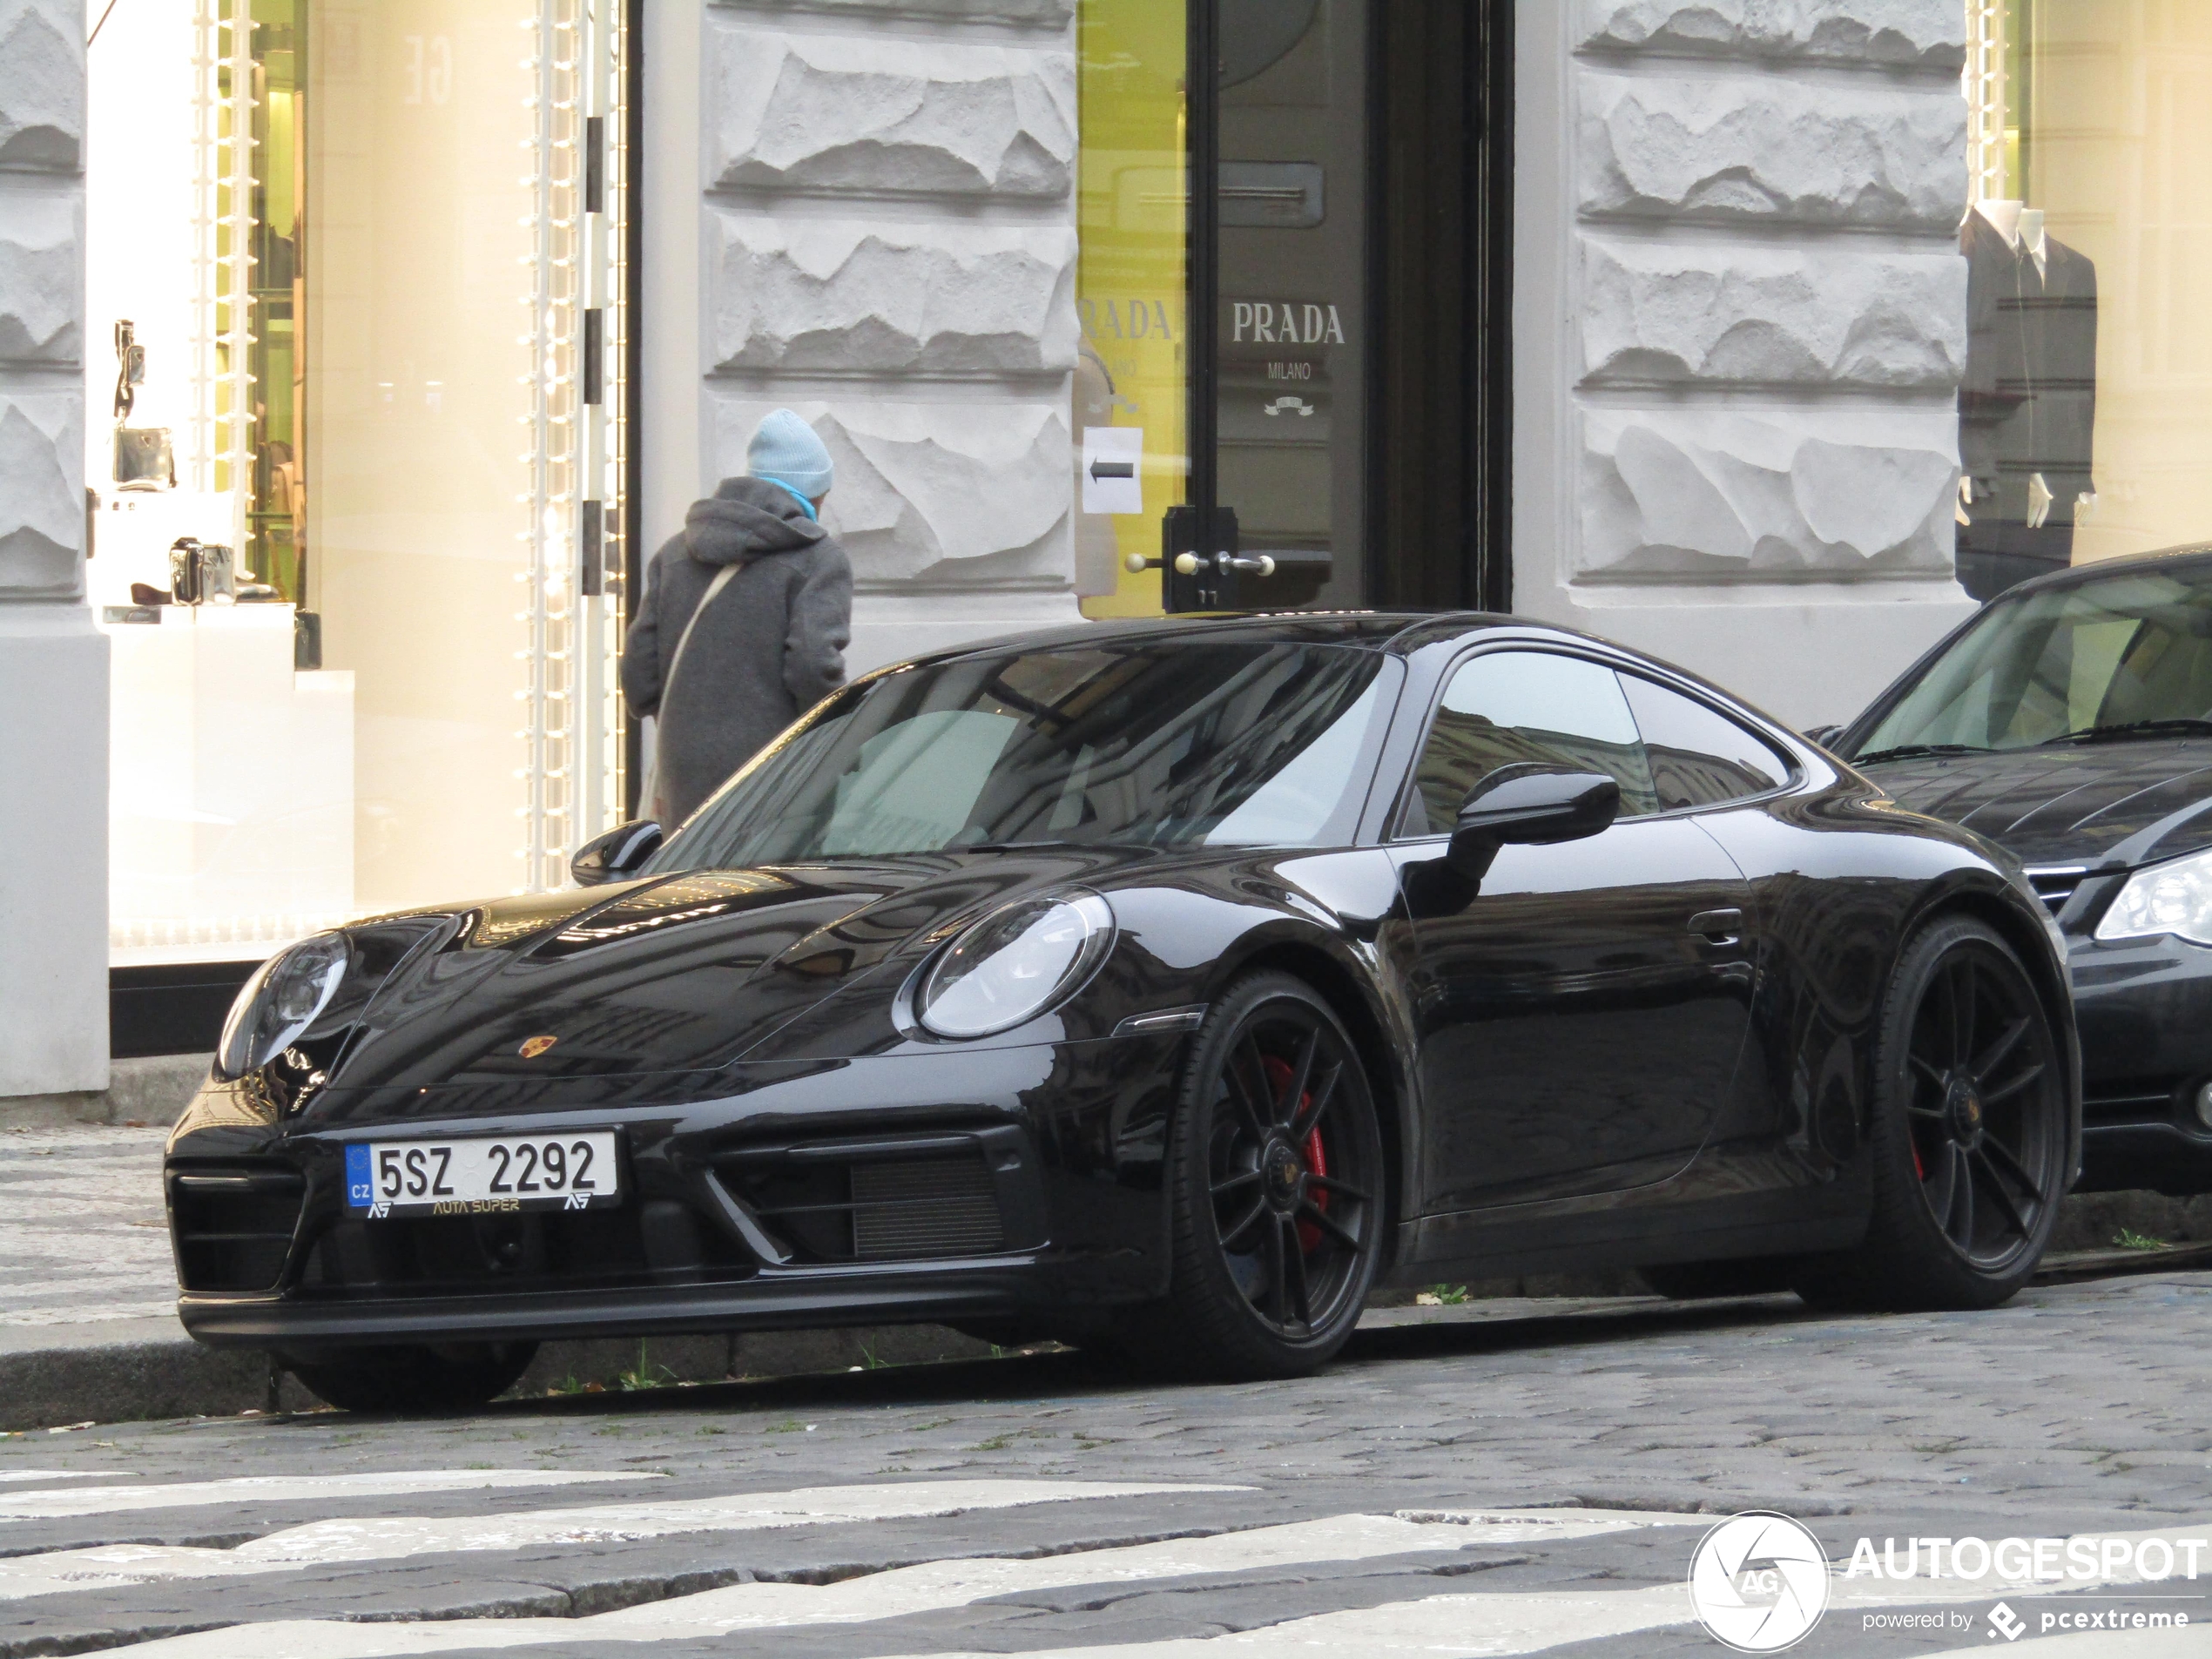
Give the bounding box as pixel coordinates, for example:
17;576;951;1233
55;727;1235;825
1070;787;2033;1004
648;642;1383;873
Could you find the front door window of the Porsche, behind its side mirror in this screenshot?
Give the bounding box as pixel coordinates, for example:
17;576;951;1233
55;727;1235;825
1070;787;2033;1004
1398;651;1659;836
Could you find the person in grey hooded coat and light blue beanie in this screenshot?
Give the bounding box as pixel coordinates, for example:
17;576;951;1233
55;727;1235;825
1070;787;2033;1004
622;409;852;830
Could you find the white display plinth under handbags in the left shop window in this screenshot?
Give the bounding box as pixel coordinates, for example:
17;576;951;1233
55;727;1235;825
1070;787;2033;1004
102;604;354;967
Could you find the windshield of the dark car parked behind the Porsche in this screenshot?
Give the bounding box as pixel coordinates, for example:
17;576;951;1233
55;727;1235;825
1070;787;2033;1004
1854;570;2212;759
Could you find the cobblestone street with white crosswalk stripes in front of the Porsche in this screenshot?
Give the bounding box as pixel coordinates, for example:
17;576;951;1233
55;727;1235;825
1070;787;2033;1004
0;1274;2212;1659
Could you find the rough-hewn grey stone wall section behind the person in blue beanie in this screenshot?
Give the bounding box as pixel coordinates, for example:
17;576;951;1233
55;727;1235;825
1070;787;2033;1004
701;0;1077;597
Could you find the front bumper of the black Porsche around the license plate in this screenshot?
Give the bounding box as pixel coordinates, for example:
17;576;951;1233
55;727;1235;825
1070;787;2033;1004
168;1033;1184;1352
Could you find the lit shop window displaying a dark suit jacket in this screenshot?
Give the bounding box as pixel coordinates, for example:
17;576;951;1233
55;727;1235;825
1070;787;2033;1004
1958;0;2212;597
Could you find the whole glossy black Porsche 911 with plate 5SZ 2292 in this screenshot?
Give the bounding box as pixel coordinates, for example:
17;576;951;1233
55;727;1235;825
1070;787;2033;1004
168;615;2080;1406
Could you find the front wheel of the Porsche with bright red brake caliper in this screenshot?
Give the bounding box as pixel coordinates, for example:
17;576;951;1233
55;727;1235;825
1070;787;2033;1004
1122;974;1385;1378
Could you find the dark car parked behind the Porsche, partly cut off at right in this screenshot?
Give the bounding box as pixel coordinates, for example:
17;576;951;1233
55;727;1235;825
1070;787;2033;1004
1834;549;2212;1195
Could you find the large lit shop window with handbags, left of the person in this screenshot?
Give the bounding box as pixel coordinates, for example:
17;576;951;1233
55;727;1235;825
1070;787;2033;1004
86;0;626;964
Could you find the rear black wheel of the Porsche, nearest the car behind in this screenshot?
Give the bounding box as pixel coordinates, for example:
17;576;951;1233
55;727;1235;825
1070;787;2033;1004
1796;918;2073;1307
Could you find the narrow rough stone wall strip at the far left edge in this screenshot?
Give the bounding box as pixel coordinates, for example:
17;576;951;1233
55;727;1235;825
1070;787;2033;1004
0;0;84;604
